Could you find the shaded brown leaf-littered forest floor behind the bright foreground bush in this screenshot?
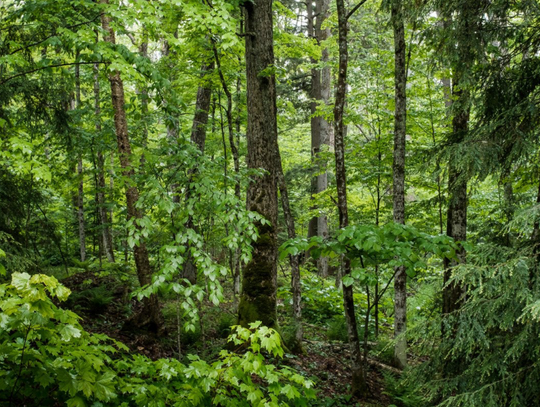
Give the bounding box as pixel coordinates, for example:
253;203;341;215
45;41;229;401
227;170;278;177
62;271;396;407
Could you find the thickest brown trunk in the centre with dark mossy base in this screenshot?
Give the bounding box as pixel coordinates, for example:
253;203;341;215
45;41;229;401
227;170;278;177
238;0;278;327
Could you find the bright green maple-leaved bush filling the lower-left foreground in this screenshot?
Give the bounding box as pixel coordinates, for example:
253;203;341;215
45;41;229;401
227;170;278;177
0;273;314;407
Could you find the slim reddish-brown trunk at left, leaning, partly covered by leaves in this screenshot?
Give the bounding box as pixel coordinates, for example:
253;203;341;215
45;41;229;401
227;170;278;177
101;0;164;333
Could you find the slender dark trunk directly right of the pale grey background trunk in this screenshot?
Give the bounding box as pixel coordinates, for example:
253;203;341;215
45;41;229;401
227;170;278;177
334;0;367;395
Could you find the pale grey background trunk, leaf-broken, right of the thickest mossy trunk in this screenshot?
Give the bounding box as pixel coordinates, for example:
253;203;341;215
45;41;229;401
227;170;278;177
307;0;333;277
